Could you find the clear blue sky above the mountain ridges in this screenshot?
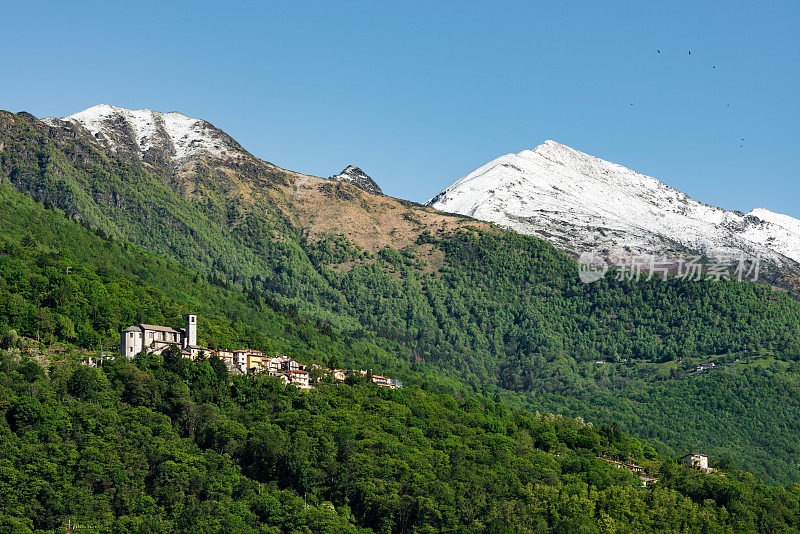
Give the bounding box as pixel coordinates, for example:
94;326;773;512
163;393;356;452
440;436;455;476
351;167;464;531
0;0;800;217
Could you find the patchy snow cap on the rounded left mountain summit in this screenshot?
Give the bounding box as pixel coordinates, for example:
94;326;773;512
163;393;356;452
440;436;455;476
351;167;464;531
42;104;243;162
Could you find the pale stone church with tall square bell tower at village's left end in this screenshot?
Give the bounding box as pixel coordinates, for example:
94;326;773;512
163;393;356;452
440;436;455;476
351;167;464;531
120;313;208;358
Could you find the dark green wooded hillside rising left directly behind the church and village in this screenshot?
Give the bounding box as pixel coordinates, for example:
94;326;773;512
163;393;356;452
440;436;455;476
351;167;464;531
0;184;412;382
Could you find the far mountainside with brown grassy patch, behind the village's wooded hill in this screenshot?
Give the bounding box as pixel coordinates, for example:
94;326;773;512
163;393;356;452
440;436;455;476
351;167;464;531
0;105;800;481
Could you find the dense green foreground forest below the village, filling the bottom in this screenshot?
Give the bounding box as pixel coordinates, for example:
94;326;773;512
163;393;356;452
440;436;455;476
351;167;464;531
0;353;800;534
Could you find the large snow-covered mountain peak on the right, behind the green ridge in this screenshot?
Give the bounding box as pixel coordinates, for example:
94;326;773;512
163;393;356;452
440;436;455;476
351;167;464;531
427;141;800;274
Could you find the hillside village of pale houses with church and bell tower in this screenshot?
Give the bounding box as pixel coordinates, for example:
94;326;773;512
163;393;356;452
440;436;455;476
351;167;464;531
120;313;403;390
